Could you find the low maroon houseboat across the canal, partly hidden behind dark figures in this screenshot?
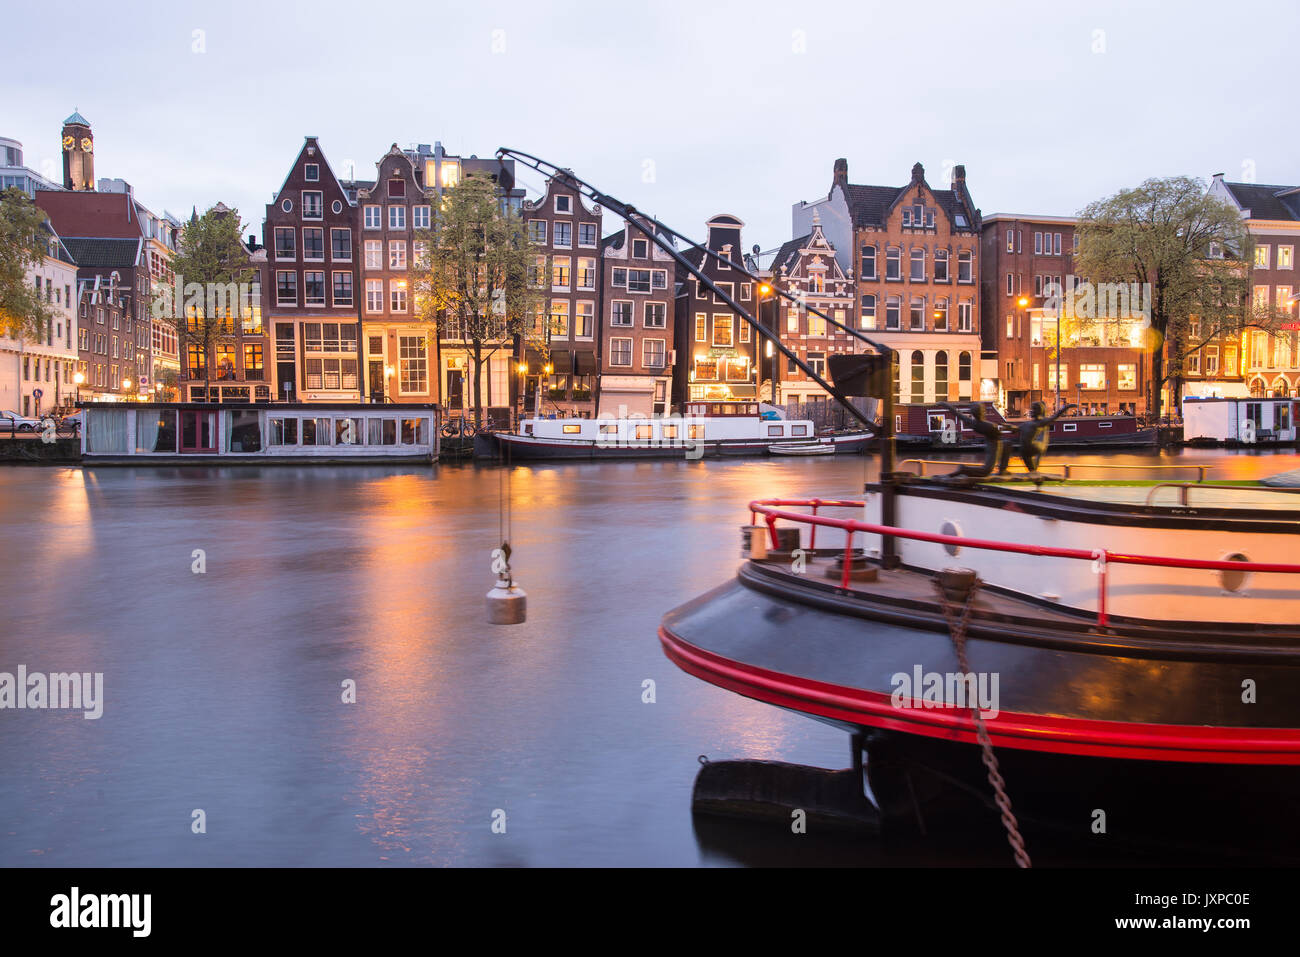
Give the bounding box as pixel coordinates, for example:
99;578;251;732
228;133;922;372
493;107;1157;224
894;402;1156;451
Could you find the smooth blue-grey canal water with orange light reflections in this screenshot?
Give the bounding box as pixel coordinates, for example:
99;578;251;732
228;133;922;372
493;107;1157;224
0;451;1300;866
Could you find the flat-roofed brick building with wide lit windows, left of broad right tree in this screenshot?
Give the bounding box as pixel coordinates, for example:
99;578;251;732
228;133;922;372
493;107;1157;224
980;213;1151;415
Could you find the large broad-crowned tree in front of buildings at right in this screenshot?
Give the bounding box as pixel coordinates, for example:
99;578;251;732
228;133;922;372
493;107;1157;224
1075;177;1268;417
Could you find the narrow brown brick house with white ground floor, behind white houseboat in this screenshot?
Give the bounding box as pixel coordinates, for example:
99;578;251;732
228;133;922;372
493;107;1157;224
598;215;677;415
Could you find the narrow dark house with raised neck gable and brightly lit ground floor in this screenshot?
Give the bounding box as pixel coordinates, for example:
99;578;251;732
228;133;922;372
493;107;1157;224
672;213;758;407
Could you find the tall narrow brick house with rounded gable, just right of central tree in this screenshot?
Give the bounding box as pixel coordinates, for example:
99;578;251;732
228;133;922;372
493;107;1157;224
520;174;602;419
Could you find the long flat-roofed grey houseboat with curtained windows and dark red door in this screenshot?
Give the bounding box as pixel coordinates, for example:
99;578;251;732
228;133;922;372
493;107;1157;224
81;402;439;465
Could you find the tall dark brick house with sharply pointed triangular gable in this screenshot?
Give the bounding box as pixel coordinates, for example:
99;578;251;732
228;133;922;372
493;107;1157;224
261;137;364;402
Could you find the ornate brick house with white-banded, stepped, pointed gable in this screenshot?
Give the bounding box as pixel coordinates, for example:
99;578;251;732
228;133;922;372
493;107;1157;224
759;209;865;403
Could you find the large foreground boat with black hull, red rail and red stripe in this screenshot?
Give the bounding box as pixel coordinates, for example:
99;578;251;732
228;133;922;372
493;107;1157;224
659;473;1300;863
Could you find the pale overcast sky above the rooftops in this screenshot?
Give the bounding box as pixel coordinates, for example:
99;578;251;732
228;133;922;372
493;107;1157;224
0;0;1300;250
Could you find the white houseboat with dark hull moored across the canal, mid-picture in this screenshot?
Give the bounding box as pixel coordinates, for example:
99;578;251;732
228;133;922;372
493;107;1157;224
475;402;871;460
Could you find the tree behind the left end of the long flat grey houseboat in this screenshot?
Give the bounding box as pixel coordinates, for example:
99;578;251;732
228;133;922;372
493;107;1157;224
161;203;257;395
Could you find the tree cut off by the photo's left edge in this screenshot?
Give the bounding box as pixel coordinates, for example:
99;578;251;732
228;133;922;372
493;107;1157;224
0;186;55;339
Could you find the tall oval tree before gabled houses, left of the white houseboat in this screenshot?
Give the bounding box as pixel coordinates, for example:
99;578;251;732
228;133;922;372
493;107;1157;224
413;176;541;428
